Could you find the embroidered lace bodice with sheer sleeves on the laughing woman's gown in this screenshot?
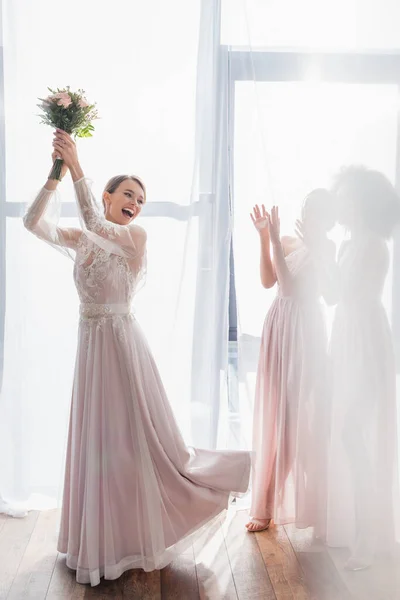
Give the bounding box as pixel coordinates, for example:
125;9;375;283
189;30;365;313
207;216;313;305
24;179;146;305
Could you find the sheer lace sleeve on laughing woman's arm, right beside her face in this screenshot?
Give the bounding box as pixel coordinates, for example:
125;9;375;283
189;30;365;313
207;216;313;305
75;178;146;259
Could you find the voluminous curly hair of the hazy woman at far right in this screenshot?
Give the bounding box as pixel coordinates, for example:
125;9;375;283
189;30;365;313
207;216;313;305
332;165;400;239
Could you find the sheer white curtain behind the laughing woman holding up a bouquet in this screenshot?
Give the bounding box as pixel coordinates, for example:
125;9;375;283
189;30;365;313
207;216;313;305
0;0;230;506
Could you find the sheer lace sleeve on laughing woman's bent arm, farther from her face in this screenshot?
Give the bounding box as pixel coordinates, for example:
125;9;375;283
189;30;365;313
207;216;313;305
23;187;81;250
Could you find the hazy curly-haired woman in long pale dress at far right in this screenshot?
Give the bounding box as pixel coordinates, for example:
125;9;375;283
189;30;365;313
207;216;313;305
327;167;400;570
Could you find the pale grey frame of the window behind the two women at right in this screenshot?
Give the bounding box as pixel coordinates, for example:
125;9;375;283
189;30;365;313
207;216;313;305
226;47;400;360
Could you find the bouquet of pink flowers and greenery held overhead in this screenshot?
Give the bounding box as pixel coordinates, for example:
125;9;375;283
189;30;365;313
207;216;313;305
38;86;98;179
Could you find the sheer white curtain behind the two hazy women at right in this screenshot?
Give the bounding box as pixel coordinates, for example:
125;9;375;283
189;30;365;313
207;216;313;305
221;0;400;447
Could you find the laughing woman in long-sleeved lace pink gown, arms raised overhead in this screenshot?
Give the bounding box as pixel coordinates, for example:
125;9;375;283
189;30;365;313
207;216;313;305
24;131;250;585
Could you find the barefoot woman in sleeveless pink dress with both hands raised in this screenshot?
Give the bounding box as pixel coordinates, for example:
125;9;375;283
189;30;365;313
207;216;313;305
247;189;335;534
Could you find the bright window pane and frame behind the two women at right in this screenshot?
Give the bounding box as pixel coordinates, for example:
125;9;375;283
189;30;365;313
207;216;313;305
227;48;400;426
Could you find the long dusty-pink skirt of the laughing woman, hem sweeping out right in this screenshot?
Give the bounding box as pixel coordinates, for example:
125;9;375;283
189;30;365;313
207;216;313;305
58;315;250;585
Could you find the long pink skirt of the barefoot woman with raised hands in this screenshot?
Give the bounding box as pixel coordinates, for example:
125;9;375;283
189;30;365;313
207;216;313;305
250;296;329;535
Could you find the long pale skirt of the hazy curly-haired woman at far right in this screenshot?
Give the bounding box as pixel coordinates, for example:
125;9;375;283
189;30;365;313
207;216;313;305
328;300;398;561
